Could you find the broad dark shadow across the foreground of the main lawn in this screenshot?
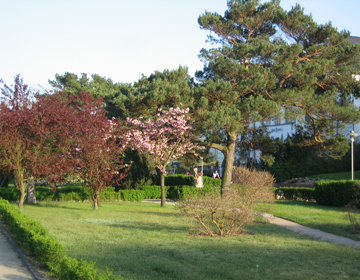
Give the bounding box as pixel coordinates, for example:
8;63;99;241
69;234;360;280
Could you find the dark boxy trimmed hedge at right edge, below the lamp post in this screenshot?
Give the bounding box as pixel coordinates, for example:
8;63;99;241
314;180;360;207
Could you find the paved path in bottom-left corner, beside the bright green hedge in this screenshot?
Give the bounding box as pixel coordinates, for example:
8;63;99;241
0;225;36;280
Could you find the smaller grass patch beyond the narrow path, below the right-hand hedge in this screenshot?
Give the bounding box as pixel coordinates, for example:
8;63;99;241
272;200;360;241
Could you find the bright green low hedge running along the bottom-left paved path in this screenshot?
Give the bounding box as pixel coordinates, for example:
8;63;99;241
0;198;109;280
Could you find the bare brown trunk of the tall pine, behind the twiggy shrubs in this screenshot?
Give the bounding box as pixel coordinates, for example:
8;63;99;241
221;132;237;196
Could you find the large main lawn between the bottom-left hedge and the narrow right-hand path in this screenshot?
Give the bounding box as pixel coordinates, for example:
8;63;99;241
20;202;360;279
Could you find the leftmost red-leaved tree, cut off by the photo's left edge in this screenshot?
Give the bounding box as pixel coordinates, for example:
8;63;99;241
0;75;79;210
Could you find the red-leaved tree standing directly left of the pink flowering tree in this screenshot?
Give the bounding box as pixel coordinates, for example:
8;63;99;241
66;93;129;210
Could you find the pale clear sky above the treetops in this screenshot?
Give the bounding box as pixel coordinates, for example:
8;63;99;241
0;0;360;88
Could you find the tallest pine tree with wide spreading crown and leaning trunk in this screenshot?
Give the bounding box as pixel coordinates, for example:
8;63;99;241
195;0;360;190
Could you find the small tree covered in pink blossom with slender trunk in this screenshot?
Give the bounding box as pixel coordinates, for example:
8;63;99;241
127;108;201;207
